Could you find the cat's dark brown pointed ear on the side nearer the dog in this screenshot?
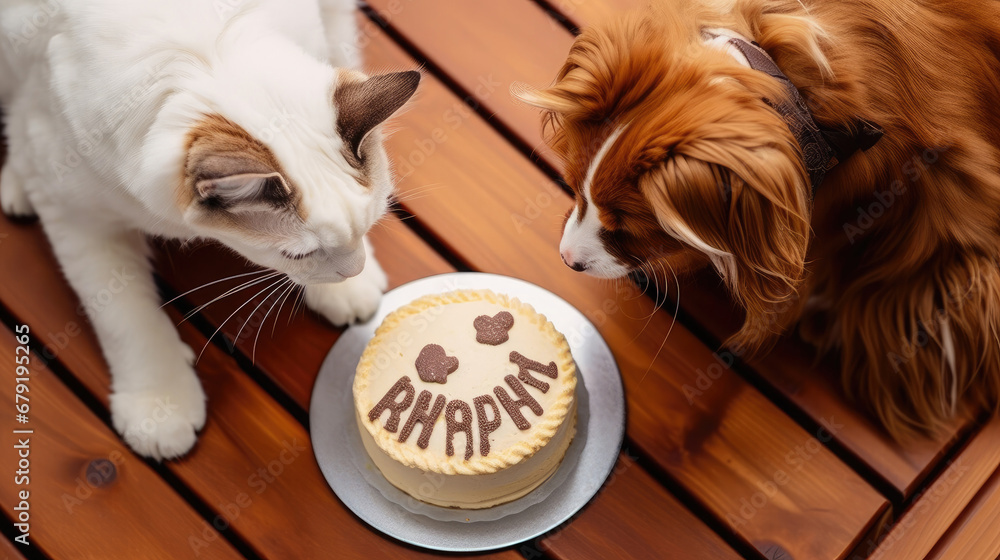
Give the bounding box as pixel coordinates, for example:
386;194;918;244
333;70;420;160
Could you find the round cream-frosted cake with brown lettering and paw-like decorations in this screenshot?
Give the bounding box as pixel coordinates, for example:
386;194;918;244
354;290;576;509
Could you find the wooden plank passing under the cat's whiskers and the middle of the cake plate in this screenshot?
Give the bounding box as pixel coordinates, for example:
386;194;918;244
150;110;744;558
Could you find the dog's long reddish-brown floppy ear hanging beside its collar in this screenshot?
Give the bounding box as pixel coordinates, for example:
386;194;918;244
639;121;809;351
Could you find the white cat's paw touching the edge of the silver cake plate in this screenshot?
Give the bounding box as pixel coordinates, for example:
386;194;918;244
305;259;389;326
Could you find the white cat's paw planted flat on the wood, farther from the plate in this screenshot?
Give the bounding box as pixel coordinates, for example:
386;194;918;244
111;370;205;461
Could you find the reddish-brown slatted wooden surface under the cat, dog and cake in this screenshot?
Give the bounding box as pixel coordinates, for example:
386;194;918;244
0;0;1000;560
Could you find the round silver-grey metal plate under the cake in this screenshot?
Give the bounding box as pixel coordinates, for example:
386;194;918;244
309;272;625;552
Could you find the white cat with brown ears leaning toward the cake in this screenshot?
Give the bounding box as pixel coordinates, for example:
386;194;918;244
0;0;420;459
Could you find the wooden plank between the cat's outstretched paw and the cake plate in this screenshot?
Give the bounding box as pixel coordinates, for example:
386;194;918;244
161;312;480;560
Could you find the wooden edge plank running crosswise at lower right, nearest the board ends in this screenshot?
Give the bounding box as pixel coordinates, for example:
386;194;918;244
857;419;1000;560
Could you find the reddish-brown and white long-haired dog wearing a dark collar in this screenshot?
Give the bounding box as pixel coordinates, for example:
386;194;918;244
516;0;1000;437
